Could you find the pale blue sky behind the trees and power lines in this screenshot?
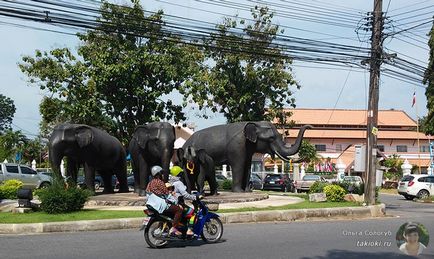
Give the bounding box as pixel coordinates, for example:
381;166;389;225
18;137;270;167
0;0;434;137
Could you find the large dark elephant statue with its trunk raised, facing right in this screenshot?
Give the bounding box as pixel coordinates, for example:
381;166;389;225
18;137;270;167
182;121;312;192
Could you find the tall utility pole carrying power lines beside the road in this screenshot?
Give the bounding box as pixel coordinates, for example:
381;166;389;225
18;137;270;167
365;0;383;205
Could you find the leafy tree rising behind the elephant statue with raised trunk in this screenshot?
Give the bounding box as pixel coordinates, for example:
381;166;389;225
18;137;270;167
186;6;299;122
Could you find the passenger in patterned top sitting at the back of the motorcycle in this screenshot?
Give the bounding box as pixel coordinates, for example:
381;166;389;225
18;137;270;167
146;165;182;236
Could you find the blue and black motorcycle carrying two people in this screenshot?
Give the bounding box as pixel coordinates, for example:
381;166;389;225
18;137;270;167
140;200;223;248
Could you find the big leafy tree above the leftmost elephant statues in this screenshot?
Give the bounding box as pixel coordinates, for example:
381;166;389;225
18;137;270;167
20;1;203;142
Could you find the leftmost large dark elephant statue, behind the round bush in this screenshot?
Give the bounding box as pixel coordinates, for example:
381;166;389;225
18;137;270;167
48;123;129;193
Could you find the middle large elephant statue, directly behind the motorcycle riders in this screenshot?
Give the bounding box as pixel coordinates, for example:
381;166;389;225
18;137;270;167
128;122;175;196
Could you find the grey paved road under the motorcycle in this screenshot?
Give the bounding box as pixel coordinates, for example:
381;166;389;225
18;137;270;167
0;195;434;259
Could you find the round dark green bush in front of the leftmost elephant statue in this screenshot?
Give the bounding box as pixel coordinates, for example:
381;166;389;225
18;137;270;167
35;179;91;214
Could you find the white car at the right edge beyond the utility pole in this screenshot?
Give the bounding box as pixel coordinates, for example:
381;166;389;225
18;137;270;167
398;174;434;200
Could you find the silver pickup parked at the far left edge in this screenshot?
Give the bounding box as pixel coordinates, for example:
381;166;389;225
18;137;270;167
0;163;52;189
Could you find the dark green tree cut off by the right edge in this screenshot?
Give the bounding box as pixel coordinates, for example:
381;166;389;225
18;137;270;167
423;19;434;135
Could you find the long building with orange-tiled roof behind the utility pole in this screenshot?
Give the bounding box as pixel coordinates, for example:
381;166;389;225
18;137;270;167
285;109;430;172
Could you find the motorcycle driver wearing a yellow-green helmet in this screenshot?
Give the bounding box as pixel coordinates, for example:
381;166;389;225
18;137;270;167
169;165;203;236
